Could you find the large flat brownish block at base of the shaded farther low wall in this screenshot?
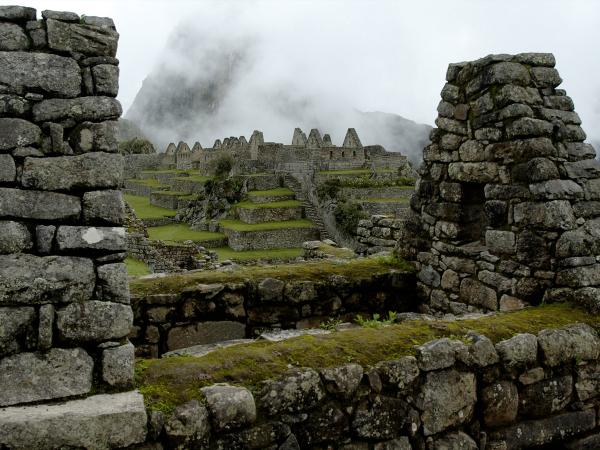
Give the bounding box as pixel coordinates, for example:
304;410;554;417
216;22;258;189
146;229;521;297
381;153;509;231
167;320;246;350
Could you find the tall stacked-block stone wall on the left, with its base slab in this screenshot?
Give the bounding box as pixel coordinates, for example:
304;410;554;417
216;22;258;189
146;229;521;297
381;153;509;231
0;6;146;448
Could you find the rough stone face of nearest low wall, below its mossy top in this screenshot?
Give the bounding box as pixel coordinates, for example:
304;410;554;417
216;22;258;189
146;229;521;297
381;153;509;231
143;324;600;450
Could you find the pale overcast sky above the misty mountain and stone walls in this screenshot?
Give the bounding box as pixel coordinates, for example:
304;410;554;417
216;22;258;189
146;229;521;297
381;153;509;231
12;0;600;141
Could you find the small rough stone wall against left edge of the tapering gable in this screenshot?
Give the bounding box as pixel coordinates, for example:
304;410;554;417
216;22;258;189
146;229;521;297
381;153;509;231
356;215;404;255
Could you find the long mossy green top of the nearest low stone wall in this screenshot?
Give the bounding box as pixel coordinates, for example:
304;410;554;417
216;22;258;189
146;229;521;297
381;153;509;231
136;304;600;411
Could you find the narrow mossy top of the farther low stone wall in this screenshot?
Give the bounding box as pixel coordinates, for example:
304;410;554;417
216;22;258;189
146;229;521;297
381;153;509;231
130;257;414;295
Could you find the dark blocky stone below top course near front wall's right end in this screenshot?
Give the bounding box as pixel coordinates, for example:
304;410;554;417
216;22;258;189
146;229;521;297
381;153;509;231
519;375;573;418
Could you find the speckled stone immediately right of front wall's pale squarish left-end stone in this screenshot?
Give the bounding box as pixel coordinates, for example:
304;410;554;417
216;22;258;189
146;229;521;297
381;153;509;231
260;369;325;416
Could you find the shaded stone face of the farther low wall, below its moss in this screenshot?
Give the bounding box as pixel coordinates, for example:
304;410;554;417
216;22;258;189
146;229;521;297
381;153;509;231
131;272;416;357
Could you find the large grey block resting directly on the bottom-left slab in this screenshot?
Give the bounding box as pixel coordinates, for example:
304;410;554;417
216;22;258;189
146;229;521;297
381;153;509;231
0;348;94;406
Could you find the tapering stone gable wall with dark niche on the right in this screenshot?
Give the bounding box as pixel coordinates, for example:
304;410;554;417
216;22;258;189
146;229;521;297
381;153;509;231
401;53;600;313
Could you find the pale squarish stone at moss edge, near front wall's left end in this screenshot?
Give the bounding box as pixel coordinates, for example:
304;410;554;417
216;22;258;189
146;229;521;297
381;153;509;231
200;384;256;431
